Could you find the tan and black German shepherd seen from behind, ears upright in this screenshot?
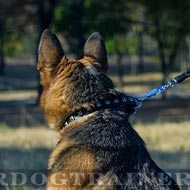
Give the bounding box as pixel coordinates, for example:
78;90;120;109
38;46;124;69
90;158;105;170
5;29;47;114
37;29;179;190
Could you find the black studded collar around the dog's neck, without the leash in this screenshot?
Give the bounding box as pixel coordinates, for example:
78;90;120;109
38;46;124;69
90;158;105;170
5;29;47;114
65;95;139;126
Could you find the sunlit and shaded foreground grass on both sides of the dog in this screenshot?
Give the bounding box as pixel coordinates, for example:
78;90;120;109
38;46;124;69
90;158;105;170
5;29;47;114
0;121;190;169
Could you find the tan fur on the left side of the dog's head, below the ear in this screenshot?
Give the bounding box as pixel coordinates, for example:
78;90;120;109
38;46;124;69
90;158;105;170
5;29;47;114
40;57;73;130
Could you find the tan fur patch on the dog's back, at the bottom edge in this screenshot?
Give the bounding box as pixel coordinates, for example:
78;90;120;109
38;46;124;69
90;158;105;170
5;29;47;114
48;146;98;190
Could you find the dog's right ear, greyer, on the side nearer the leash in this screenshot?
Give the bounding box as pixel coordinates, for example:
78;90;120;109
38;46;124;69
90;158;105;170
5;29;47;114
84;32;108;72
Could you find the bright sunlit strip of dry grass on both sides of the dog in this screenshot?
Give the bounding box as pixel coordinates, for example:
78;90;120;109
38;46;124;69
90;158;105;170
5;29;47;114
0;122;190;152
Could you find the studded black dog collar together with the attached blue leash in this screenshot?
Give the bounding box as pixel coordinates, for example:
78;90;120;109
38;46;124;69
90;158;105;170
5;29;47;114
65;70;190;125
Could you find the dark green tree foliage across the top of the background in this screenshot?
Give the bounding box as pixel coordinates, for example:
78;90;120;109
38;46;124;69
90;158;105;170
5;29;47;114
0;0;190;73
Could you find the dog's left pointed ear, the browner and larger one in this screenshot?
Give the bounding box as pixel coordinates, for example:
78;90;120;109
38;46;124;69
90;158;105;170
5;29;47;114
38;29;64;68
